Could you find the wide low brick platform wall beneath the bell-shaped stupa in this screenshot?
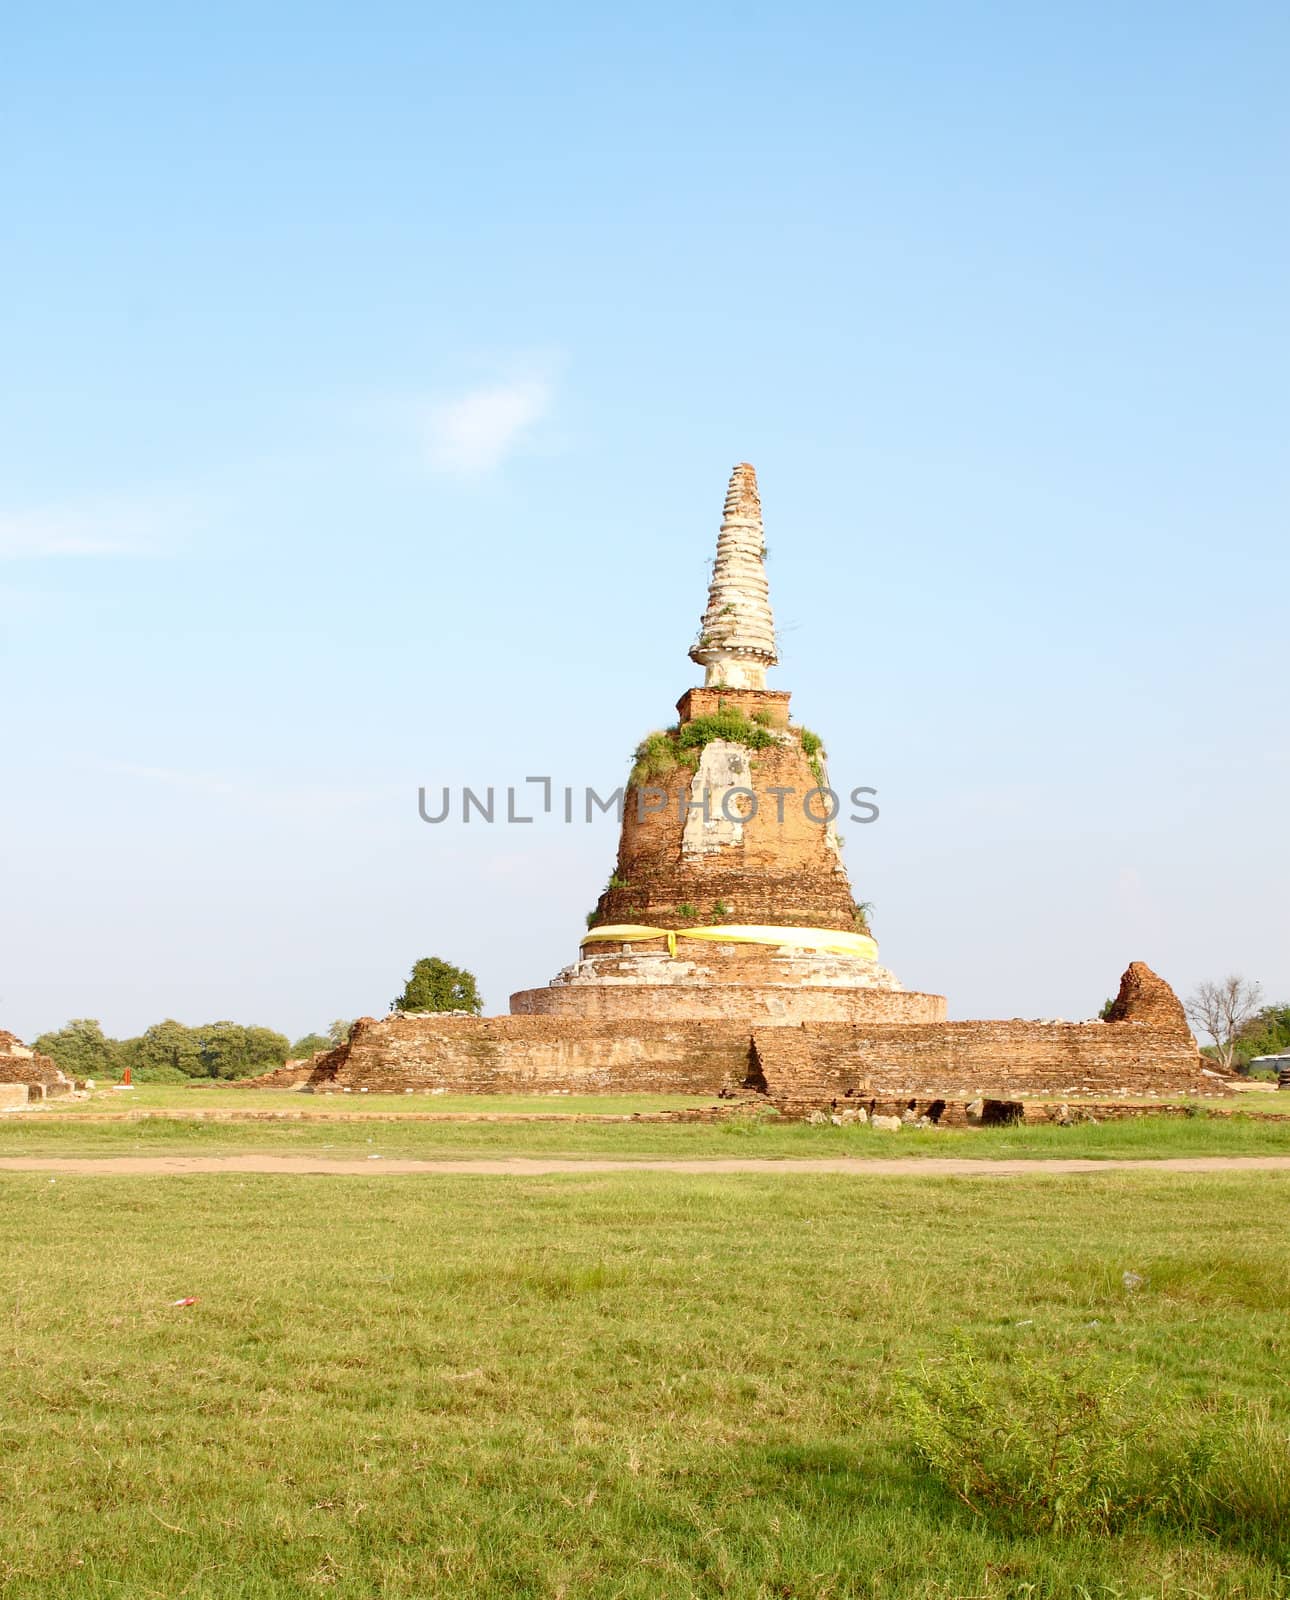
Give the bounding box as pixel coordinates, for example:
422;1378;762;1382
307;968;1223;1115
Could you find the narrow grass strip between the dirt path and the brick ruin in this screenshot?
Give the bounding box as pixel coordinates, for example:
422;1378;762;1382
0;1090;1290;1160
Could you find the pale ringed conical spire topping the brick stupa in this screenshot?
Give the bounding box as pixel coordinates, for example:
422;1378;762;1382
690;461;779;690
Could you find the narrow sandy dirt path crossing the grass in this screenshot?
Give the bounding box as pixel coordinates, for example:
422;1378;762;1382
0;1155;1290;1178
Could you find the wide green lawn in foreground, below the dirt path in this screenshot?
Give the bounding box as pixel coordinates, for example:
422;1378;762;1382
0;1171;1290;1600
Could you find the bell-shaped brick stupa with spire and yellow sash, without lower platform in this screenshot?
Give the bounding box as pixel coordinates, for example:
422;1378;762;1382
511;462;944;1022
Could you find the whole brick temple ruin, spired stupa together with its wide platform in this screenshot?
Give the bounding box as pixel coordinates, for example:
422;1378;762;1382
272;464;1218;1114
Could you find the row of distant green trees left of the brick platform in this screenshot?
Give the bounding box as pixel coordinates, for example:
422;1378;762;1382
34;1018;351;1083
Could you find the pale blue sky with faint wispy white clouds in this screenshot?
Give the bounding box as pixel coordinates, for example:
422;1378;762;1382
0;3;1290;1037
